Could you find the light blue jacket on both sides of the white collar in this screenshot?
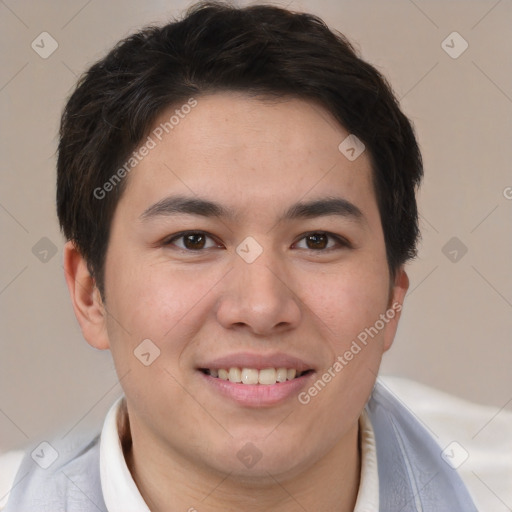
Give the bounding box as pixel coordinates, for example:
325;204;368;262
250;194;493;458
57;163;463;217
5;382;478;512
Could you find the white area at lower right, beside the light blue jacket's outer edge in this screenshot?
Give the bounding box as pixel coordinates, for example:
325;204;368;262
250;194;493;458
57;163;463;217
379;377;512;512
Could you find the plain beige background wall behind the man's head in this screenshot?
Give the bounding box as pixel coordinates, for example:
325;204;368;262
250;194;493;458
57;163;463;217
0;0;512;452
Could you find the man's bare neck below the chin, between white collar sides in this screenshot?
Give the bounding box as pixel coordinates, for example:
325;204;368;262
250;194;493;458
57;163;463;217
122;412;361;512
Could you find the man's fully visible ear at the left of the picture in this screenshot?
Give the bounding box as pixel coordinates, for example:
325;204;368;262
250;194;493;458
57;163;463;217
64;242;109;350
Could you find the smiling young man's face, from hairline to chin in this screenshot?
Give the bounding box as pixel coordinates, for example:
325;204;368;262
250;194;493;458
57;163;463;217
82;93;406;482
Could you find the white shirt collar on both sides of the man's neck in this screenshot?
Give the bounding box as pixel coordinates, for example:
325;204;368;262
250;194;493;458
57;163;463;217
100;397;379;512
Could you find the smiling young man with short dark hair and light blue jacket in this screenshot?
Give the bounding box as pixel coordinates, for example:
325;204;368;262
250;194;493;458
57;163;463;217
0;4;508;512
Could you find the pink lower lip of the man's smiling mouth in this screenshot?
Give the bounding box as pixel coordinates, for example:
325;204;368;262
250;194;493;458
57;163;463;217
199;371;314;407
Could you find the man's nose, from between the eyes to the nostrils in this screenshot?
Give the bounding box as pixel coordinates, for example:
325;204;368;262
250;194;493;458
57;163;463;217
216;251;302;336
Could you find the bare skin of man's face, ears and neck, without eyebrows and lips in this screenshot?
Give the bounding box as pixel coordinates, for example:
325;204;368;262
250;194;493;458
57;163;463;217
65;93;409;512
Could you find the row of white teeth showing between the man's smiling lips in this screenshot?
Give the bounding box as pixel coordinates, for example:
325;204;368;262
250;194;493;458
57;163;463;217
199;367;313;386
